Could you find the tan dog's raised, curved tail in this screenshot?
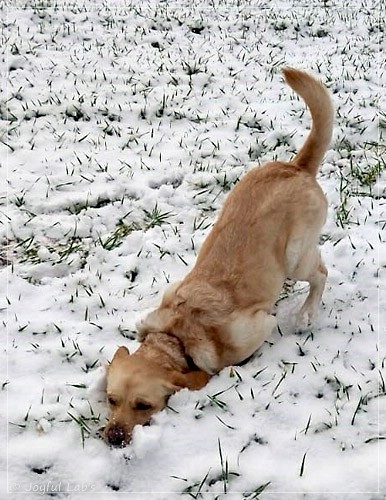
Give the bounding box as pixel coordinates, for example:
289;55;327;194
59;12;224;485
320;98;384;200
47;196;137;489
283;68;334;176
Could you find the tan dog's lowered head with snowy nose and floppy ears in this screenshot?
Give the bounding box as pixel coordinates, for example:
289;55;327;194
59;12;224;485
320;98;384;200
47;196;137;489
104;347;209;446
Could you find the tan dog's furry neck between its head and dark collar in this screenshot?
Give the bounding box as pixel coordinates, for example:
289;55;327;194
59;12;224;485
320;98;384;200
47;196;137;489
137;332;198;373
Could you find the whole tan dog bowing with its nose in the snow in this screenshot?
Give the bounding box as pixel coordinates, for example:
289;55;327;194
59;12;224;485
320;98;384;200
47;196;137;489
106;68;333;444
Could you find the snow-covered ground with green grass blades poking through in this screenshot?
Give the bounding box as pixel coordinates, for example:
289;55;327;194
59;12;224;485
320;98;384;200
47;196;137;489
0;0;386;500
